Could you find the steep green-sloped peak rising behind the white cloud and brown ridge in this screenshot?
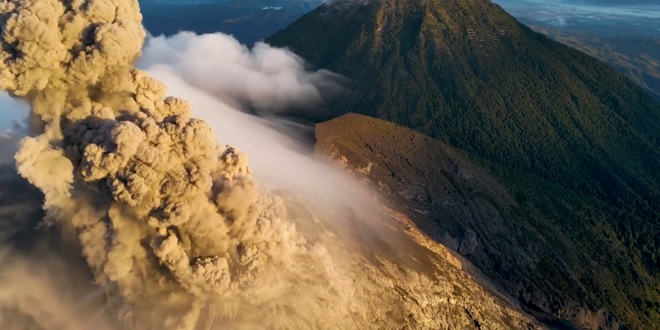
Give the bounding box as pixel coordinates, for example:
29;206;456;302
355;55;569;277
267;0;660;201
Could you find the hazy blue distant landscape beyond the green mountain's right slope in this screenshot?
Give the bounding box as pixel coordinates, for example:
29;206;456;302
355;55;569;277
495;0;660;101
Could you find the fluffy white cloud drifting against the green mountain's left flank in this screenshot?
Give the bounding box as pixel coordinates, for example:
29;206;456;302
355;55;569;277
138;32;342;112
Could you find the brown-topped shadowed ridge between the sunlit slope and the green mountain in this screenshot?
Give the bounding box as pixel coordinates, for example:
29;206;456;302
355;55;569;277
316;114;660;329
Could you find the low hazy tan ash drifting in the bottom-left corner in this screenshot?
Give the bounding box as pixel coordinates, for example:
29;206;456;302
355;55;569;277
0;246;119;330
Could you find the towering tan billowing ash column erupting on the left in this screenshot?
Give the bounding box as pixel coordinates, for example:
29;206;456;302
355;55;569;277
0;0;320;328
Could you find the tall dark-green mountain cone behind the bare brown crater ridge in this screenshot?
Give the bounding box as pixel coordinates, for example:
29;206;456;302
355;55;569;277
268;0;660;211
